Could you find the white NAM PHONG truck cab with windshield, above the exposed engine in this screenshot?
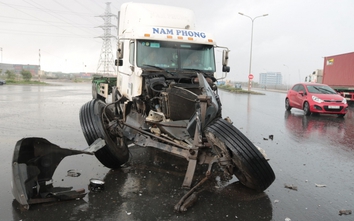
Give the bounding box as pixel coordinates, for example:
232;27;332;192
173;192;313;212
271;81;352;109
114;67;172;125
113;2;228;99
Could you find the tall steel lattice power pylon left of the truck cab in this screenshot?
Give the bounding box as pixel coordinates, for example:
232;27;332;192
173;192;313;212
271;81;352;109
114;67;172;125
96;2;118;75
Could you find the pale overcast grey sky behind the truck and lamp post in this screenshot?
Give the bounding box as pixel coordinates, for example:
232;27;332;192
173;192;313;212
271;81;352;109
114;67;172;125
0;0;354;84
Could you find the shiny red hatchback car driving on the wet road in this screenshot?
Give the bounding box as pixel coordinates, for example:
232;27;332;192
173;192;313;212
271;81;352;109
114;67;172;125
285;83;348;117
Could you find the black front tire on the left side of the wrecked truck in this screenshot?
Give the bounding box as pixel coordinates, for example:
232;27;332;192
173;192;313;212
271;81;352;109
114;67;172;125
80;99;129;169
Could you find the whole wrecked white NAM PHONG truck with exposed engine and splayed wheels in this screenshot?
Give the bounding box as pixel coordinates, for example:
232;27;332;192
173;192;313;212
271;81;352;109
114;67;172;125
85;3;275;211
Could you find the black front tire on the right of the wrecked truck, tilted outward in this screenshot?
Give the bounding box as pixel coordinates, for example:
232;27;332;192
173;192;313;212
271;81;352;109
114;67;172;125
205;118;275;192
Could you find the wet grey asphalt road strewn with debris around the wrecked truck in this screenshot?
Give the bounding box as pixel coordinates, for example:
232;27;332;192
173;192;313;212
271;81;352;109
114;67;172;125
0;83;354;221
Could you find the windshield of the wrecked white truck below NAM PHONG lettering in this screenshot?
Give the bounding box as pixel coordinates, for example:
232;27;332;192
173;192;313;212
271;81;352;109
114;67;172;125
137;40;215;72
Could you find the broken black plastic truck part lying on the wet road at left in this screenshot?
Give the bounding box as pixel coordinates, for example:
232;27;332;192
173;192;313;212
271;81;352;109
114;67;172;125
11;137;106;209
